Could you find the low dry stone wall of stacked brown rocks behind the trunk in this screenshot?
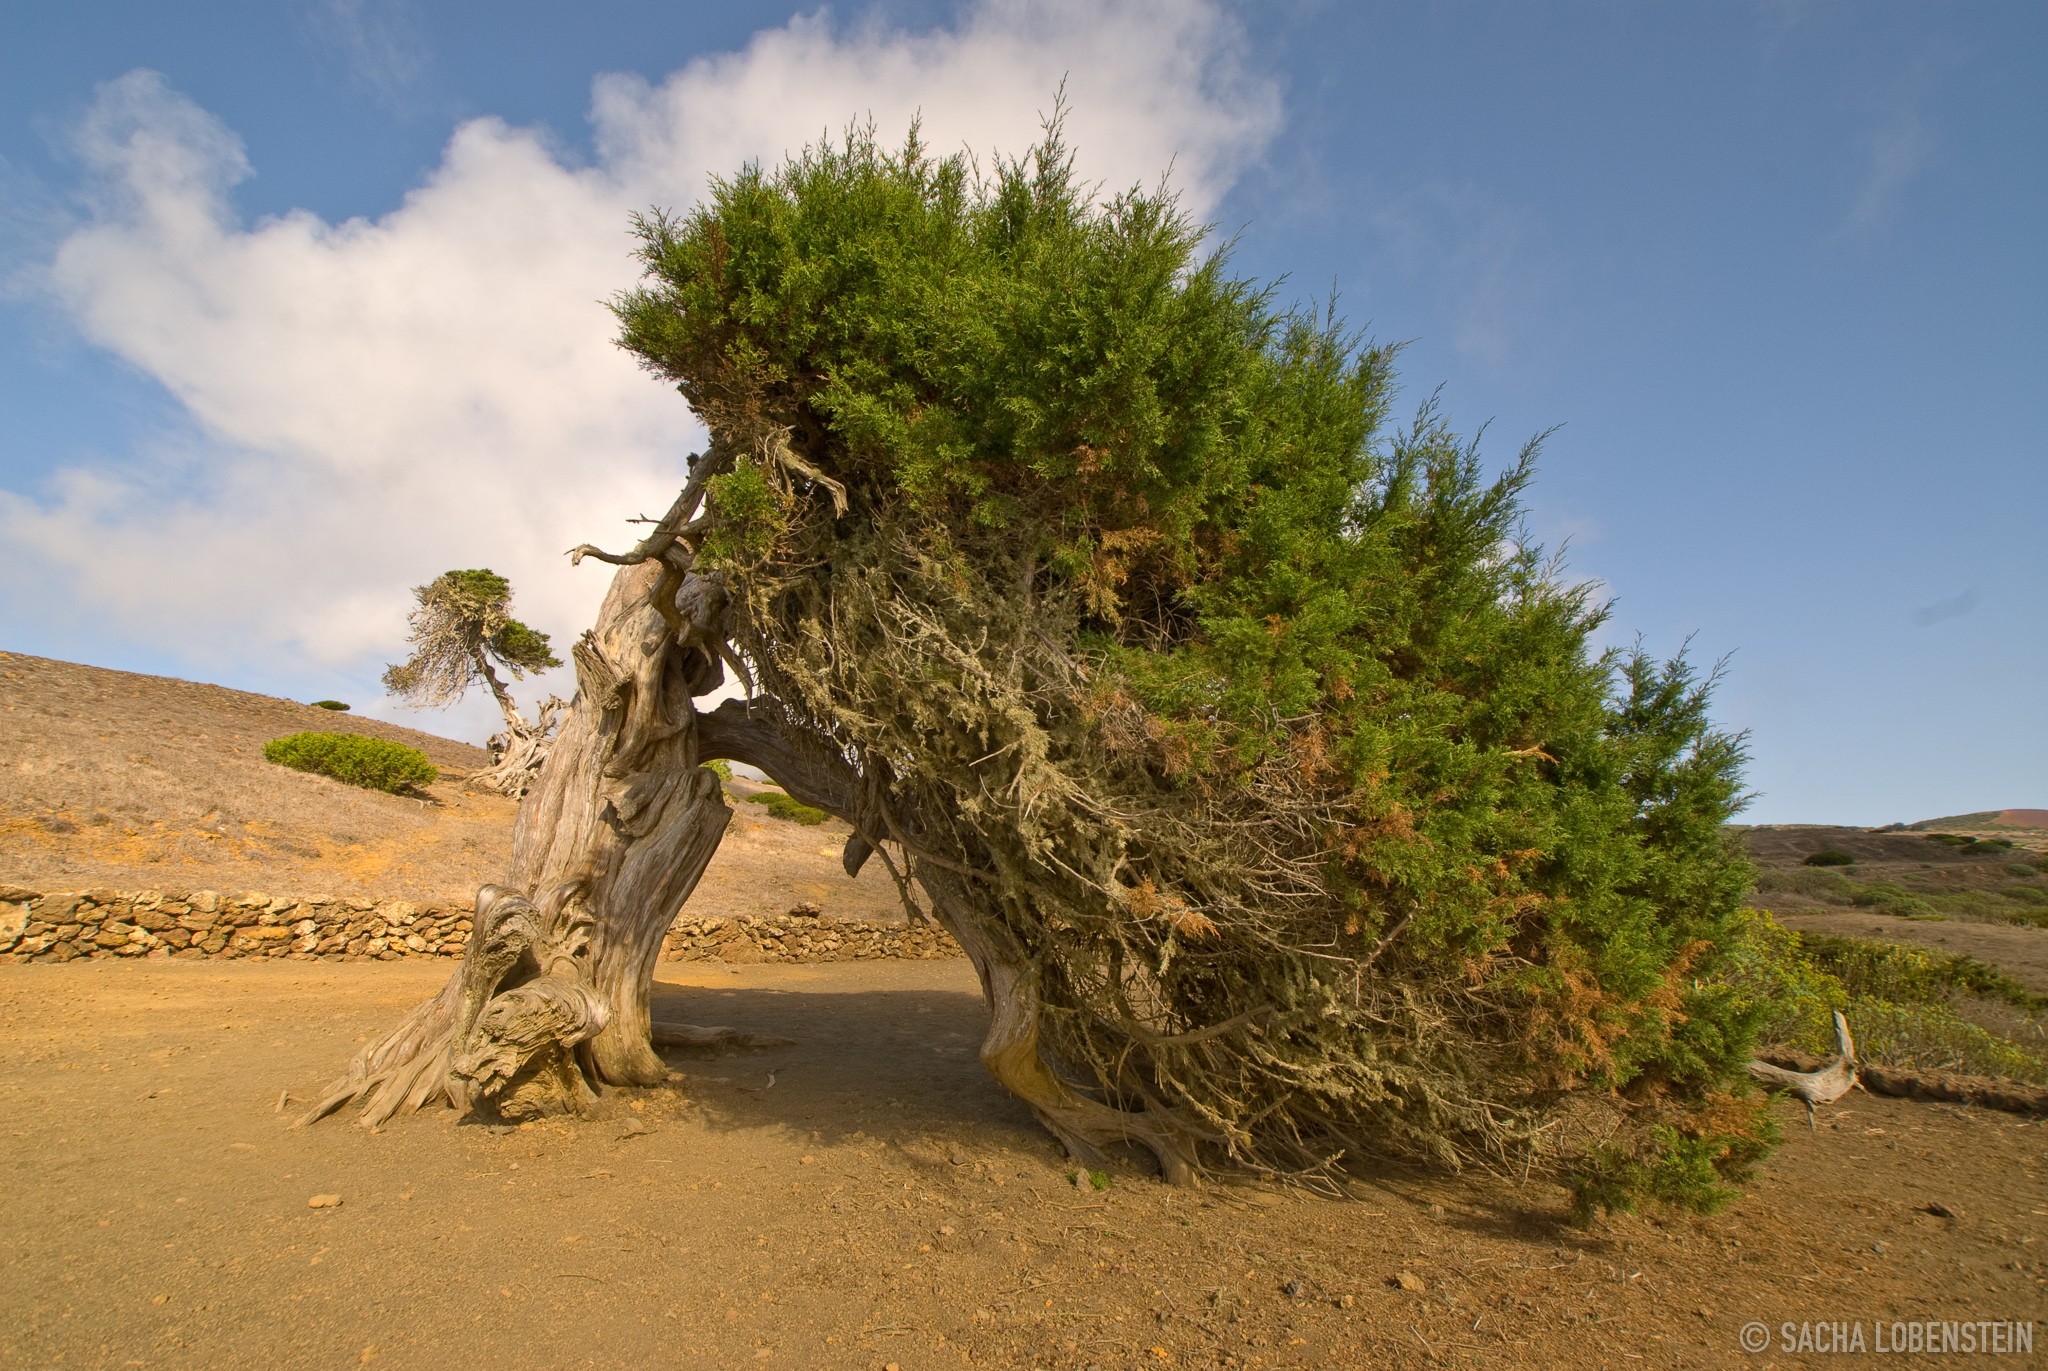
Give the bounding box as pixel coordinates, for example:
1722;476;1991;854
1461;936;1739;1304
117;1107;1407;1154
0;885;961;963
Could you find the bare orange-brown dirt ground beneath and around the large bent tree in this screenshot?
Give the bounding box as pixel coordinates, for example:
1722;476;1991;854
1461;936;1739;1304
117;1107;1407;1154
0;961;2048;1371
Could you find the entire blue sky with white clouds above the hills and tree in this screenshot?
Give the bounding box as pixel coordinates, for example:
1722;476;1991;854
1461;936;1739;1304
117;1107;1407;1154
0;0;2048;824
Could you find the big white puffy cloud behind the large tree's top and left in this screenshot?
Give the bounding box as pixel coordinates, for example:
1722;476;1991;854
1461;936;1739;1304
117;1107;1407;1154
0;0;1280;737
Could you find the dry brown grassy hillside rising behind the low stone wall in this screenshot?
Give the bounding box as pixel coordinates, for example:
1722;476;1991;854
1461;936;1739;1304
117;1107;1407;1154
0;654;903;922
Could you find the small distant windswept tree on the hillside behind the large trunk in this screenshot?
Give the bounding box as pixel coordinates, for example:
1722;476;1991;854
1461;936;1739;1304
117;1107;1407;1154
383;568;563;795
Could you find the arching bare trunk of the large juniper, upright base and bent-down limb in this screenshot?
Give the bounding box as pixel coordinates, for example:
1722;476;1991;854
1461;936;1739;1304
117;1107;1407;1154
301;459;1217;1185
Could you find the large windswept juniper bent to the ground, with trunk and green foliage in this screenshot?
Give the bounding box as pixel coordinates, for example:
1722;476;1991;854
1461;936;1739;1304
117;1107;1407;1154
307;120;1761;1199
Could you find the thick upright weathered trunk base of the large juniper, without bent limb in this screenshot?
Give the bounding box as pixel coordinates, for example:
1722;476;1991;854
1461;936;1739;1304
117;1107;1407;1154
303;562;753;1125
